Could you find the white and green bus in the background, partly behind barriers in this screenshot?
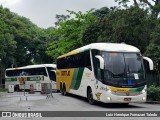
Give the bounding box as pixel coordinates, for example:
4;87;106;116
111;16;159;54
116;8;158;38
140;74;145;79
5;64;56;91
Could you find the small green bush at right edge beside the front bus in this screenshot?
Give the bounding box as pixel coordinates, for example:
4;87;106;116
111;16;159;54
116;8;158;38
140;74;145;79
147;85;160;101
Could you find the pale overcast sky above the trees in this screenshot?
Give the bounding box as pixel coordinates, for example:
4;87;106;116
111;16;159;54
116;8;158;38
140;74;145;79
0;0;117;28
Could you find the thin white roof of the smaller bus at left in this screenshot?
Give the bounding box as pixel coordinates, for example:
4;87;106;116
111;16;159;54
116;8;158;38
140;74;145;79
6;64;56;70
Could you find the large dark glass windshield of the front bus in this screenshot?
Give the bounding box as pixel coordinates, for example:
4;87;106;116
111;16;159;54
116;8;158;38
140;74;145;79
102;52;144;81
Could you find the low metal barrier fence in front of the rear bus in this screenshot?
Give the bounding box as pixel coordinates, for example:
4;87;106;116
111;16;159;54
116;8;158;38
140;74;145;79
0;83;53;104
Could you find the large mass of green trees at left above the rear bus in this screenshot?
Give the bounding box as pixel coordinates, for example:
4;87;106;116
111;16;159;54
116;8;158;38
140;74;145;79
0;6;52;68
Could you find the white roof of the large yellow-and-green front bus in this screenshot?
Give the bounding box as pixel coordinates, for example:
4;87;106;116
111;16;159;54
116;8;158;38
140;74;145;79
58;43;140;58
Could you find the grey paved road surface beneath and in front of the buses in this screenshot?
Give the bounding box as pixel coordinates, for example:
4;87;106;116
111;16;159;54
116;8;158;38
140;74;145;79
0;92;160;120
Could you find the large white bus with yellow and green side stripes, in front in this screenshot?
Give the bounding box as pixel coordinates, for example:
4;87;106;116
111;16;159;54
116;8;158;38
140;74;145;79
56;43;153;104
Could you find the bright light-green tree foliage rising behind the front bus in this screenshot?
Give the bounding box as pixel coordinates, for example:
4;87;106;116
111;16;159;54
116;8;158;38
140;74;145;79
47;10;96;59
